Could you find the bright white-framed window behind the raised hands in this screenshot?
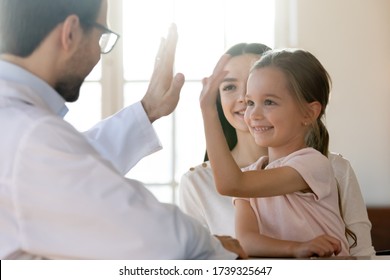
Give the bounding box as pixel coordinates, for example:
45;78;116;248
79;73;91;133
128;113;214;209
66;0;275;203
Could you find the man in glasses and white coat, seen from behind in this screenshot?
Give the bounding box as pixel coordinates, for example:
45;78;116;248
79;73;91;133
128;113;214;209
0;0;246;259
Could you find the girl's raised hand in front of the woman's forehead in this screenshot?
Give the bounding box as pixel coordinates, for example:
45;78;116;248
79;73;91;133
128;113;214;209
199;54;230;110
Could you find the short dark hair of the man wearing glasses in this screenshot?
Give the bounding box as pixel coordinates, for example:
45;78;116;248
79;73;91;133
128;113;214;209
0;0;102;57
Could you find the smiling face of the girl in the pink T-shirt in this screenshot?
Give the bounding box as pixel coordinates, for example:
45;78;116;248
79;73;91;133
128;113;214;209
245;67;307;157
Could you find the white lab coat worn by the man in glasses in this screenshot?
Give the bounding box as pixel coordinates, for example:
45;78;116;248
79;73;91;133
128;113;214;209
0;61;236;259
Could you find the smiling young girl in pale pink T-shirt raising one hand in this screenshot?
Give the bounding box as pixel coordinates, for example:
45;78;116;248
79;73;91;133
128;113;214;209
200;50;349;257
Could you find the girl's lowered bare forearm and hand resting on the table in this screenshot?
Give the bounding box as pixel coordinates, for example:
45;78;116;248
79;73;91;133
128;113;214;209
235;199;341;258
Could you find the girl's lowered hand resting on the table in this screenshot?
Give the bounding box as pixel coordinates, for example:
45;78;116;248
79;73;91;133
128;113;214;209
293;234;341;258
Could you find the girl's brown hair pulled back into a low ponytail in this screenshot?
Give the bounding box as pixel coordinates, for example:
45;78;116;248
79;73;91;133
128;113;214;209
251;49;331;156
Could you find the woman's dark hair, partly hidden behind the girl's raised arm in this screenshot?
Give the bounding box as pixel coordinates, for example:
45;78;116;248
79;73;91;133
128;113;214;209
204;43;271;161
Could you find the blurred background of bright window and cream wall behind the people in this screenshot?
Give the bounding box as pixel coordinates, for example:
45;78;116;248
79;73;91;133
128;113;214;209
66;0;390;206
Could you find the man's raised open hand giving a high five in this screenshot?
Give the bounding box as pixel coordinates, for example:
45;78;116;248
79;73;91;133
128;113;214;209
141;24;184;122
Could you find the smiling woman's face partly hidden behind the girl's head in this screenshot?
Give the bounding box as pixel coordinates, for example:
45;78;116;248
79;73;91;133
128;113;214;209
219;54;260;131
